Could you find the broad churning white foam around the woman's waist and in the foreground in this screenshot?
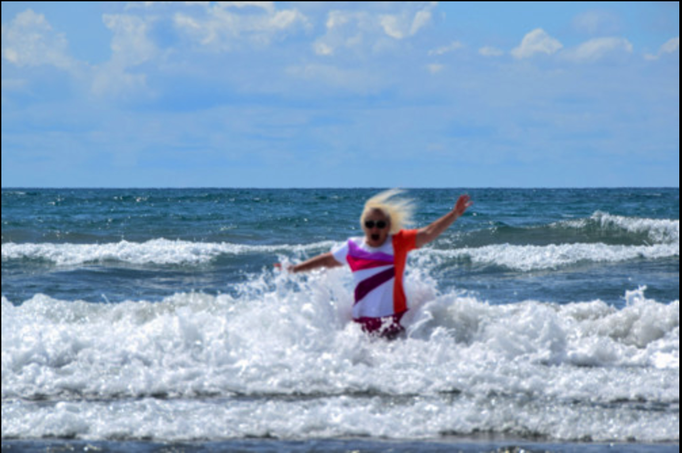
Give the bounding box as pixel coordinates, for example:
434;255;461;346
2;270;679;441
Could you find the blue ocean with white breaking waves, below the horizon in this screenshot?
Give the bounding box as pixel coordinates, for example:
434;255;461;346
2;188;680;453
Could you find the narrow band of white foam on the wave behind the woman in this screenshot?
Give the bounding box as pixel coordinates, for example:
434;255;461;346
2;235;680;272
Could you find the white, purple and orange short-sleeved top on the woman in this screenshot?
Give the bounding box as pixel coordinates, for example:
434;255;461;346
332;230;417;333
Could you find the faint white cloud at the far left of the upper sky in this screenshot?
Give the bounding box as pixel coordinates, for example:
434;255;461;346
2;9;76;71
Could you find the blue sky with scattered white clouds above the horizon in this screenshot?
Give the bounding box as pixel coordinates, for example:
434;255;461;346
2;1;680;188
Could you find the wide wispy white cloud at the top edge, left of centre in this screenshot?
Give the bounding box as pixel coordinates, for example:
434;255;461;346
174;2;311;52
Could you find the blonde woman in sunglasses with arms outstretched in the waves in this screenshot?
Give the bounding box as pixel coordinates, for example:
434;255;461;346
278;189;473;337
